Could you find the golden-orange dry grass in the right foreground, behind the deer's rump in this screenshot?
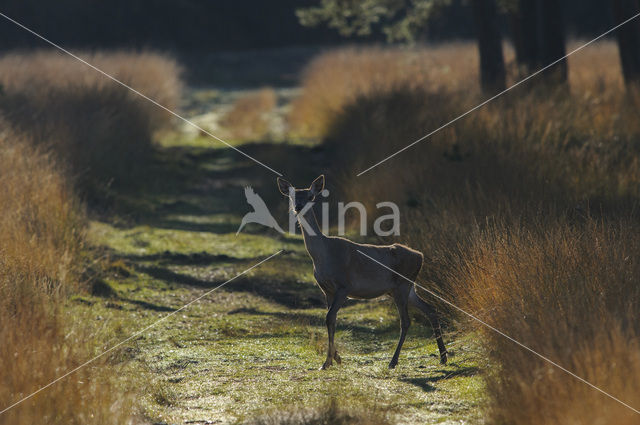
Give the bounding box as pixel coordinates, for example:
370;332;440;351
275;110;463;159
455;221;640;424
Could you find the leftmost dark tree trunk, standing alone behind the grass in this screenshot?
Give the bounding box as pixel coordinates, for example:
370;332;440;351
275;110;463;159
472;0;506;94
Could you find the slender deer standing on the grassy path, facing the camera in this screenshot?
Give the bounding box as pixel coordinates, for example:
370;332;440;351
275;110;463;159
277;175;447;370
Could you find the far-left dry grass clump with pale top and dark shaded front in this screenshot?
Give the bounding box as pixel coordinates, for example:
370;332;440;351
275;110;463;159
0;51;181;191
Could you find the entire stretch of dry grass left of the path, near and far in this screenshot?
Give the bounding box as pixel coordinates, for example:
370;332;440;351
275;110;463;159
0;51;180;424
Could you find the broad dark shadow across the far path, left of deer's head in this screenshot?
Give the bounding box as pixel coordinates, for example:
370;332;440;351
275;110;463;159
109;142;327;229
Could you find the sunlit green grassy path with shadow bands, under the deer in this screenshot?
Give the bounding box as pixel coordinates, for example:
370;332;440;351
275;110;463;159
74;98;482;424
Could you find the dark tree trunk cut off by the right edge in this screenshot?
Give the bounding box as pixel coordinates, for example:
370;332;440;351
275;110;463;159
612;0;640;86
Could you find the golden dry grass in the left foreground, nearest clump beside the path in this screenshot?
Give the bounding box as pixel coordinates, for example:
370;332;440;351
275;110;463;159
0;124;129;424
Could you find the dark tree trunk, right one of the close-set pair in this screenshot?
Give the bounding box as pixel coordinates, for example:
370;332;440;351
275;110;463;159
539;0;567;85
